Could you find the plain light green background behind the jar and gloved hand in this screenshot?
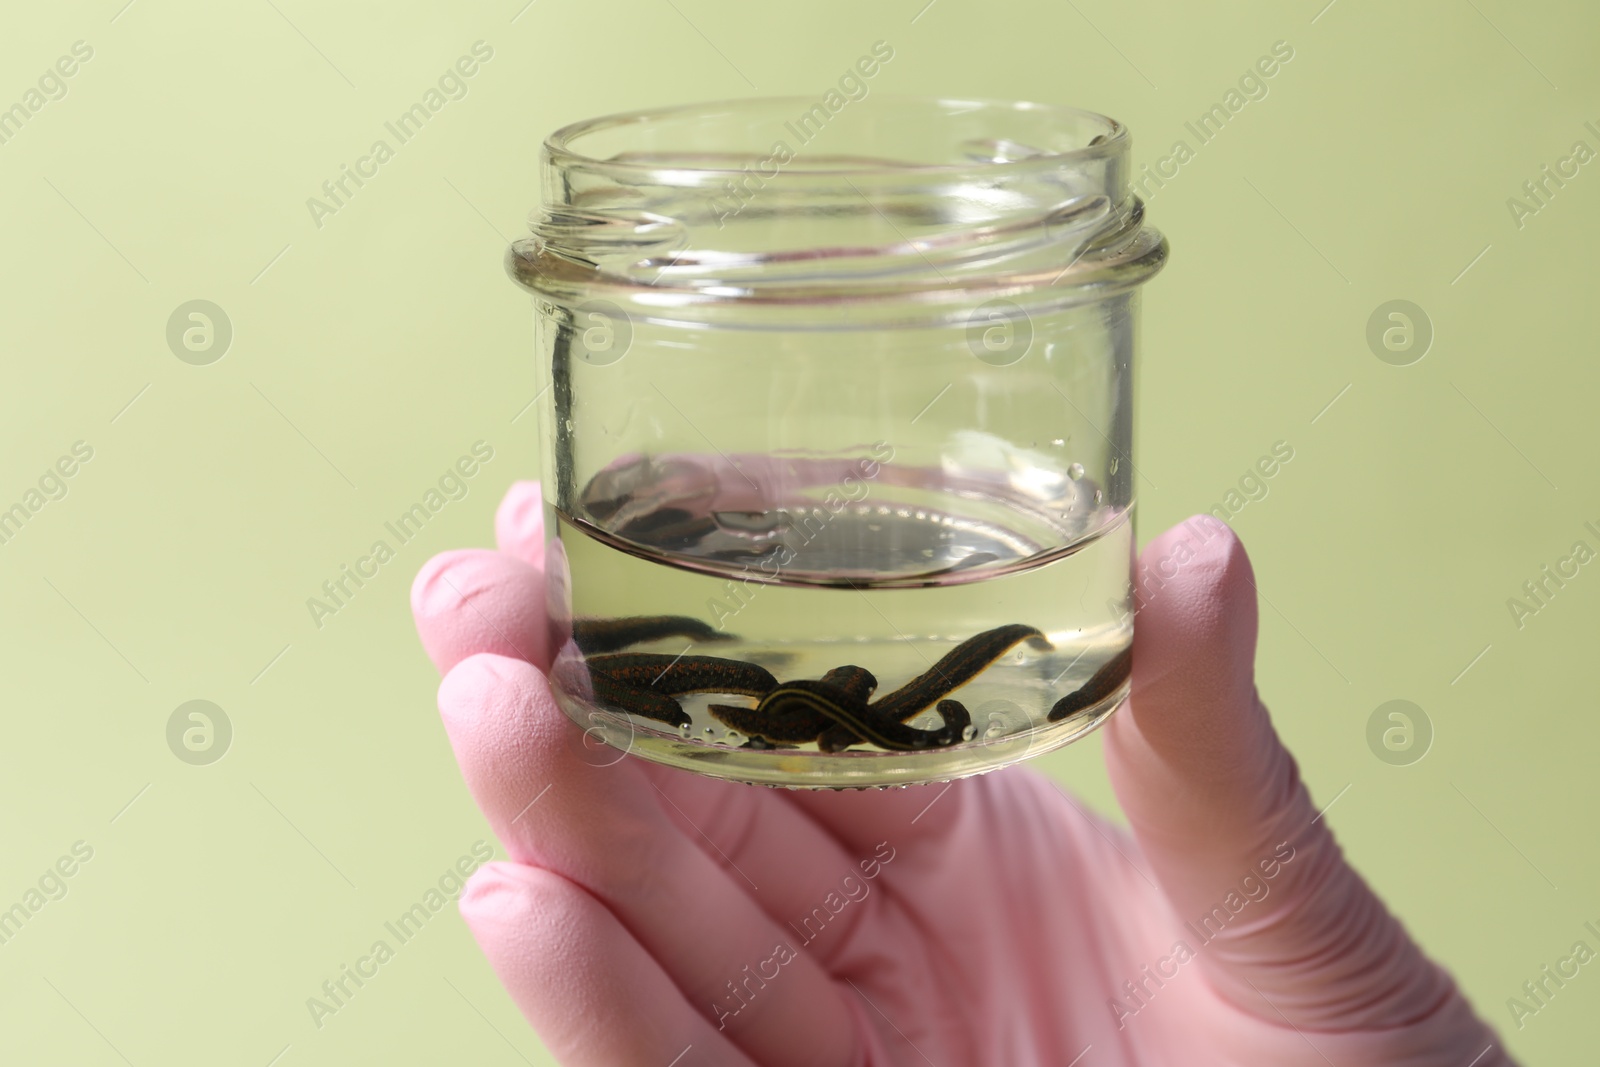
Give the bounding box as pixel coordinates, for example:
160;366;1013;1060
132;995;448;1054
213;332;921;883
0;0;1600;1067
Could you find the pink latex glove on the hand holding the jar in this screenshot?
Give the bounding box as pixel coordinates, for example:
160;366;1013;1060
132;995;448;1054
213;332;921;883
411;483;1512;1067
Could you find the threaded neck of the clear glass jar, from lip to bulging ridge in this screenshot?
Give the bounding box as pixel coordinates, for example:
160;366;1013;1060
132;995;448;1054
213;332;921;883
521;97;1166;328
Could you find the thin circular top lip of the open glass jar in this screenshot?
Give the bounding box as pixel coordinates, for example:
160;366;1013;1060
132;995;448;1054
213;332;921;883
544;93;1130;178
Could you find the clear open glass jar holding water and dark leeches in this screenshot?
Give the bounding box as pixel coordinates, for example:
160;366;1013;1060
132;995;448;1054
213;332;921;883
507;96;1166;787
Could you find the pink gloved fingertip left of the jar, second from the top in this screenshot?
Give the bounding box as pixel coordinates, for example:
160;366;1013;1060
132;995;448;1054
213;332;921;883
411;549;550;672
